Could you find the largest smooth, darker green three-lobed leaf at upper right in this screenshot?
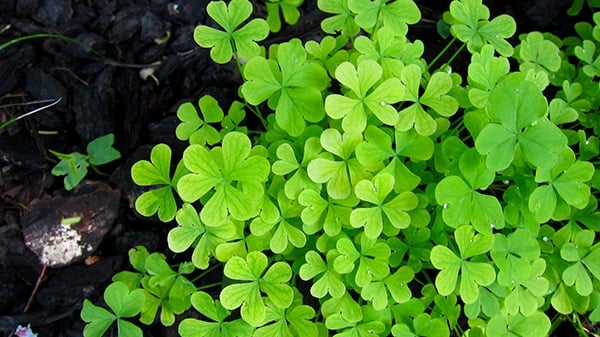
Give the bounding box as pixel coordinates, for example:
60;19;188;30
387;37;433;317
475;75;567;171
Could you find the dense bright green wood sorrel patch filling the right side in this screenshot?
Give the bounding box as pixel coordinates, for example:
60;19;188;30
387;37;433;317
82;0;600;337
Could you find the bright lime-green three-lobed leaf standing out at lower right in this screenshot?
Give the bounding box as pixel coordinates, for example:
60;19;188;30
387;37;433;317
431;225;496;303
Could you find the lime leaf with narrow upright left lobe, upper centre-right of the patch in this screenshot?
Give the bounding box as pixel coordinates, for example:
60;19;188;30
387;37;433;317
396;64;458;136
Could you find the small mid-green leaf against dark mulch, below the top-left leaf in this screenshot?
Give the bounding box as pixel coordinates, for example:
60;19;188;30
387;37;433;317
175;95;224;145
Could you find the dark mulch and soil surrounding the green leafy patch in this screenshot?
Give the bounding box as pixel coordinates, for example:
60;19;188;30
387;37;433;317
0;0;592;337
